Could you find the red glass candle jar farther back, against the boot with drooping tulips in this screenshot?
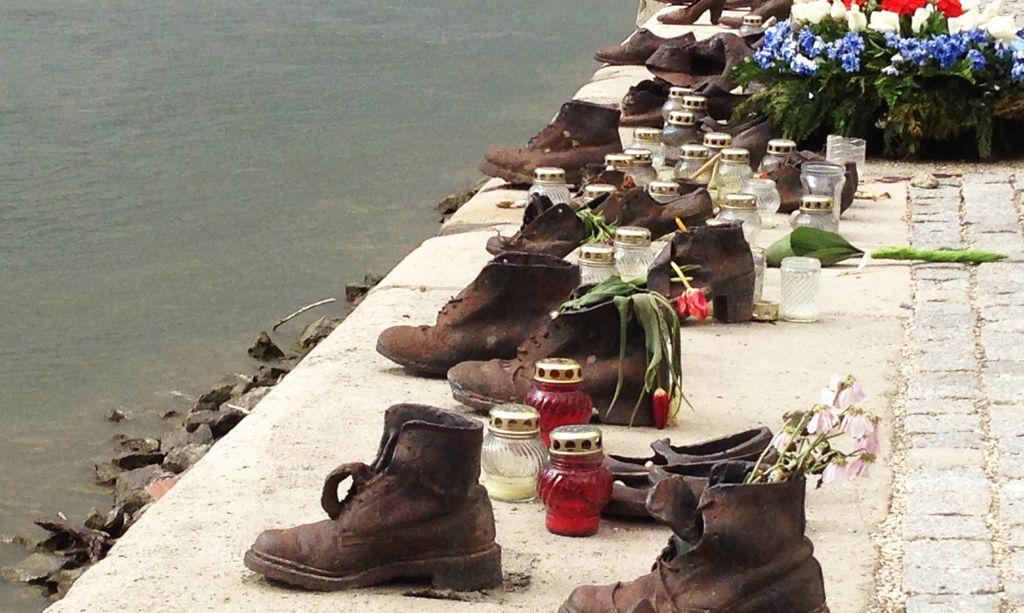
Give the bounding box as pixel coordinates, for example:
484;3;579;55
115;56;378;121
525;357;594;445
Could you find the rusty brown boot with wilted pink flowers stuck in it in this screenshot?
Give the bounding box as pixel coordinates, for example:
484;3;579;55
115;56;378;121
560;463;828;613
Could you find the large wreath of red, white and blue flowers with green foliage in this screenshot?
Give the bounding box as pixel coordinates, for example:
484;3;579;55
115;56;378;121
735;0;1024;159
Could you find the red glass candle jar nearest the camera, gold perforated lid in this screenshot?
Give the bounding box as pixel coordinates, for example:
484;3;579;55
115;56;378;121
537;426;612;536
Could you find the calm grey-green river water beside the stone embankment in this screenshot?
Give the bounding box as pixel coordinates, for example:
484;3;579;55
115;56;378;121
0;0;635;611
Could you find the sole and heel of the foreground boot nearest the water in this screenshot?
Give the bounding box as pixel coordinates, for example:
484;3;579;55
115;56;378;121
245;543;502;592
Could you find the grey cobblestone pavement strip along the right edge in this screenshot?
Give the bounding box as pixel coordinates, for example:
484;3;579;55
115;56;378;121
879;173;1024;613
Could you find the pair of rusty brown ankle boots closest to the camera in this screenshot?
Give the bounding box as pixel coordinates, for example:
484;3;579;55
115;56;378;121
245;404;827;613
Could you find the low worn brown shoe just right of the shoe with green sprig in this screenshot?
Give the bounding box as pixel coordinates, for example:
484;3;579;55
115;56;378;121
605;183;715;239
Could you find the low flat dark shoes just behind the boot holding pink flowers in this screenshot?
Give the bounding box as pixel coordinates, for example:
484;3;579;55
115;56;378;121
601;428;774;519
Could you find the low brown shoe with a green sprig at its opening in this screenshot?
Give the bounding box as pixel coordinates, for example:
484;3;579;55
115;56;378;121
481;193;615;257
